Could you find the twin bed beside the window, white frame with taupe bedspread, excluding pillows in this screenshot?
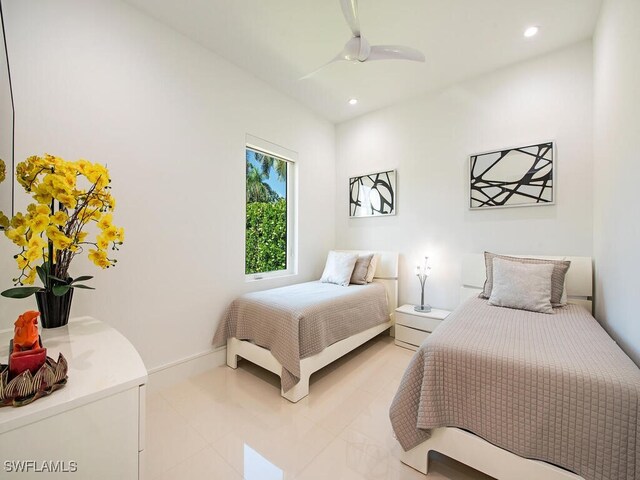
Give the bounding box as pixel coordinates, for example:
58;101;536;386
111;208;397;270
214;251;398;402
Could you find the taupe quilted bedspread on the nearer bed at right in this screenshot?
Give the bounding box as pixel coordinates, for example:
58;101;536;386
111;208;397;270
389;298;640;480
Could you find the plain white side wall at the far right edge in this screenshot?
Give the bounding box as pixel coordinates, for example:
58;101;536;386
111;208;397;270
594;0;640;364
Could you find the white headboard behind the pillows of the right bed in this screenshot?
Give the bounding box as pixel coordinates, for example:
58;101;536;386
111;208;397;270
460;253;593;312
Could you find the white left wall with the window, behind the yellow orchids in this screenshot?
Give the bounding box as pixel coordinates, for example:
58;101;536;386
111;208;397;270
0;0;335;368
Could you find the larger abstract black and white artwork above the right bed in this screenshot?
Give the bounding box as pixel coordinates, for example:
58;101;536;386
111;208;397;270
469;142;554;210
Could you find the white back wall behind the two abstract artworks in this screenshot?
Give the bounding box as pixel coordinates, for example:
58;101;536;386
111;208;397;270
336;42;593;308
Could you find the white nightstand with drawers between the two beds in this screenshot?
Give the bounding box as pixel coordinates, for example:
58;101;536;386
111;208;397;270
396;305;451;350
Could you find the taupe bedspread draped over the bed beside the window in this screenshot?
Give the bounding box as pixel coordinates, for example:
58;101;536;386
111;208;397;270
213;282;389;392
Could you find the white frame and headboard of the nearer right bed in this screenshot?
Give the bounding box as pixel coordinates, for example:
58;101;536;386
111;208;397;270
401;254;593;480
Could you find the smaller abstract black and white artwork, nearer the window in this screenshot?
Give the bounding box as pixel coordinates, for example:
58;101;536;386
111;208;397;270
349;170;396;217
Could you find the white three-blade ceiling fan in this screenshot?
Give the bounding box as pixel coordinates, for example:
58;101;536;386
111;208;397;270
301;0;425;80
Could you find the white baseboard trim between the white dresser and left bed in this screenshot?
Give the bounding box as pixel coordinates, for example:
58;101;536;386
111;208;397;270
147;347;227;394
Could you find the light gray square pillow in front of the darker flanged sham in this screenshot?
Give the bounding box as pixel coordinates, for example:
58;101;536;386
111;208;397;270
489;258;554;313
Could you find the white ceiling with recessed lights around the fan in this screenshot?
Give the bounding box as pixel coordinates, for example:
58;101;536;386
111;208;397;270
126;0;601;122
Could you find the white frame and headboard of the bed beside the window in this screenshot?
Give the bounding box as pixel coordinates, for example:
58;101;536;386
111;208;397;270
227;250;398;403
